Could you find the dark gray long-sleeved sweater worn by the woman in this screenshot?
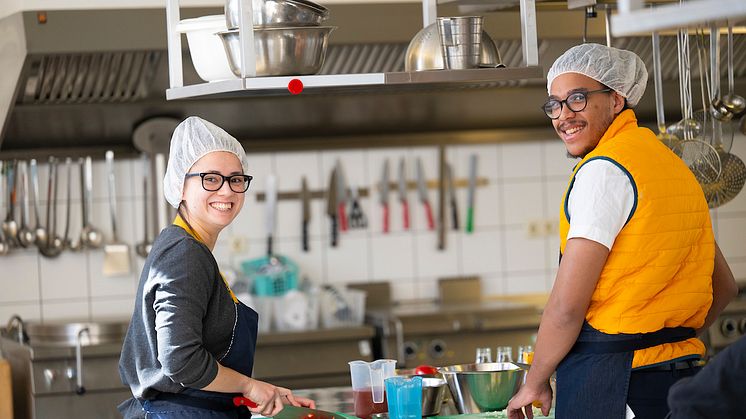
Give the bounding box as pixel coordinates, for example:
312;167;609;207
119;225;236;399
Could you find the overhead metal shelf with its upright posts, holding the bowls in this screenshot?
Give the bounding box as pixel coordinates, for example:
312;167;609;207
166;0;544;100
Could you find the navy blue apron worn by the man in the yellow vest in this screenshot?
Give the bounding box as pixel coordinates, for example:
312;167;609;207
555;322;696;419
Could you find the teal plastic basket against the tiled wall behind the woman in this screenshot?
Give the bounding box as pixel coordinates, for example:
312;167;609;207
241;256;298;297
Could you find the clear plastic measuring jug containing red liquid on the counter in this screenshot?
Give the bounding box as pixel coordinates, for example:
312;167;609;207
348;359;396;419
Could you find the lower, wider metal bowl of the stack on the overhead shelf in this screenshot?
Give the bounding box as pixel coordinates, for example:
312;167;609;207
218;26;336;77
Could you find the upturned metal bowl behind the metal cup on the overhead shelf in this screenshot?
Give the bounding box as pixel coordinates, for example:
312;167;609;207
404;23;503;71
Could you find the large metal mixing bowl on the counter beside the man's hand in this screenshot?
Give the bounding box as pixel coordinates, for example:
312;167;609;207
440;362;526;414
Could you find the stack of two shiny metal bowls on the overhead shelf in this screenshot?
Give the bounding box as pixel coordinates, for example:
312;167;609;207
218;0;335;76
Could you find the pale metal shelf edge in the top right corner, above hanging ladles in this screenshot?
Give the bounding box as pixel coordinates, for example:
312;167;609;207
611;0;746;37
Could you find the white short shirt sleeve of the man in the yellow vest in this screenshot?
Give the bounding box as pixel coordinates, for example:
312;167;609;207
567;159;635;250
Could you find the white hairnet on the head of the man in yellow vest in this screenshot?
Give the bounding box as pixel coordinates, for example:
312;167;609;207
547;44;648;107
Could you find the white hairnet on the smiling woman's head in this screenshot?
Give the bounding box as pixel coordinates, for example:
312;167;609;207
163;116;249;208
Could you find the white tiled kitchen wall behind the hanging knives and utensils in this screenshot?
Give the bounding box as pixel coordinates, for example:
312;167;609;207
0;136;746;322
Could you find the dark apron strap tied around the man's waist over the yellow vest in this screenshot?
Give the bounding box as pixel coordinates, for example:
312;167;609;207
570;327;697;354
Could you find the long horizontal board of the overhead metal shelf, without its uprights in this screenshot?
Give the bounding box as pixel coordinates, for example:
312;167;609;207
166;66;544;100
